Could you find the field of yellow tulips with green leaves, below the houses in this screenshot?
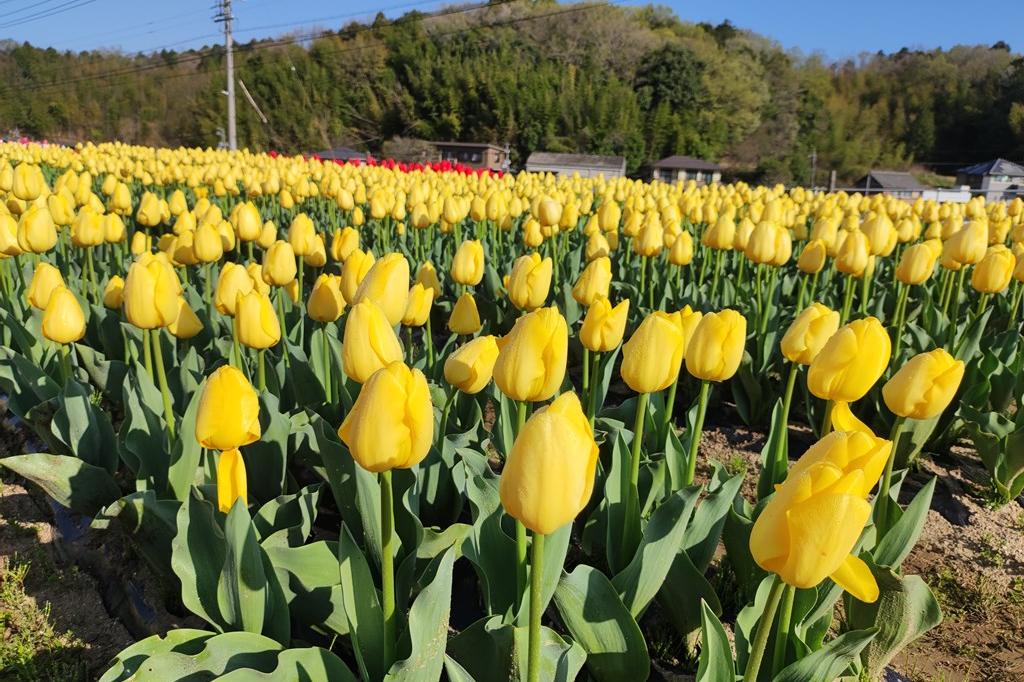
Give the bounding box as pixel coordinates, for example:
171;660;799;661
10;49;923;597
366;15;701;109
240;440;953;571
0;143;1024;682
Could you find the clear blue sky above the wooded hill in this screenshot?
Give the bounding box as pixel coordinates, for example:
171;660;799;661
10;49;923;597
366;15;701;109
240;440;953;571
6;0;1024;58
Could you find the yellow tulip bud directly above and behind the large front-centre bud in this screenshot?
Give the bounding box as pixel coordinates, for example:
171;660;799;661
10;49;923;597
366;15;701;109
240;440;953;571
495;307;568;402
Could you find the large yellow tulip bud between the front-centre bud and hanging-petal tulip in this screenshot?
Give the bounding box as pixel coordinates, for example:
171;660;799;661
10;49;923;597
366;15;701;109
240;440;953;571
338;360;434;472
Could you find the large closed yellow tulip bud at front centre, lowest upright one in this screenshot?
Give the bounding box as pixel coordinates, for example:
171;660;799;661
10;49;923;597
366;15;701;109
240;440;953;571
498;392;598;534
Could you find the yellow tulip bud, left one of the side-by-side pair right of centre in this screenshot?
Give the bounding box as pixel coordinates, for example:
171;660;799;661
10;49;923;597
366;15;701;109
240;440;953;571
621;310;686;393
